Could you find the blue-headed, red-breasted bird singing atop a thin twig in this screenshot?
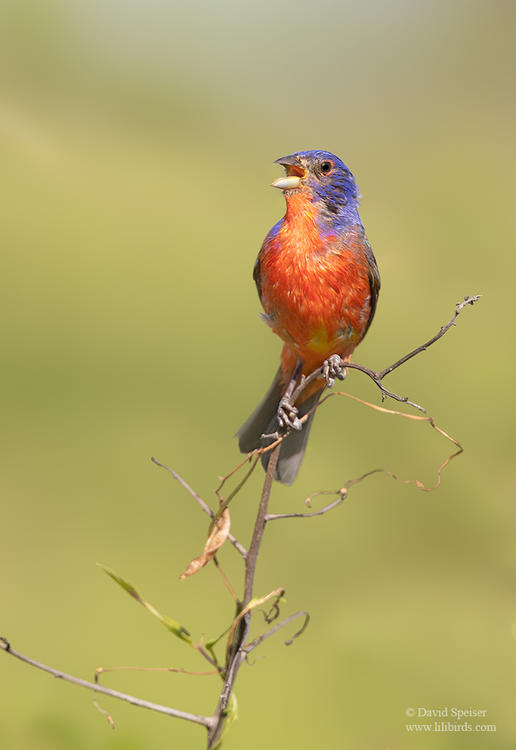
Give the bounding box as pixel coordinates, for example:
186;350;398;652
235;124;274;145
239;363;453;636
237;151;380;484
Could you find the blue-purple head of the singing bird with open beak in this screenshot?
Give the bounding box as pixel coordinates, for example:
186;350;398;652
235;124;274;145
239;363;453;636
272;150;360;226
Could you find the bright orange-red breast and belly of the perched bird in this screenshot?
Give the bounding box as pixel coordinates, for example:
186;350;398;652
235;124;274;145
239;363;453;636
259;191;371;395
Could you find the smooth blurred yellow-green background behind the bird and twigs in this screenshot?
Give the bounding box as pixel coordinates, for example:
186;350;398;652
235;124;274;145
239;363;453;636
0;0;516;750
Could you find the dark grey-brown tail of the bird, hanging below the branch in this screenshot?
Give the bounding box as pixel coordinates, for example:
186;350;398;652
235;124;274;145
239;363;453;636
237;368;323;484
